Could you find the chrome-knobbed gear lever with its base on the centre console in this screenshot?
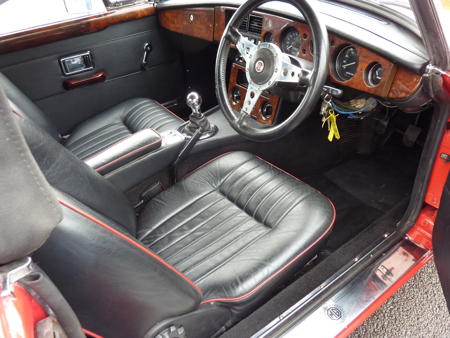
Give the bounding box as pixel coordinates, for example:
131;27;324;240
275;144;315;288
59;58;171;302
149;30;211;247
181;92;217;139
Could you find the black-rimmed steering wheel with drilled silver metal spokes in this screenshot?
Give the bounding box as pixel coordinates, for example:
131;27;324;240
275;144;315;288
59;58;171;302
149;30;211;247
215;0;330;141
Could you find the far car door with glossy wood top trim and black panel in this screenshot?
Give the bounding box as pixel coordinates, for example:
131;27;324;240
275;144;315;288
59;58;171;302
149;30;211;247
0;0;184;133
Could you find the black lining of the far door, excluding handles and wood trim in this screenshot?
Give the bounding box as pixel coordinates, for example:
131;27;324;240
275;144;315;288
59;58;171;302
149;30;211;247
0;16;184;133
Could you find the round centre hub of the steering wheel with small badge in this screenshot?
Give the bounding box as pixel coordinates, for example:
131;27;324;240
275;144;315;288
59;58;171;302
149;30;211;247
247;43;279;89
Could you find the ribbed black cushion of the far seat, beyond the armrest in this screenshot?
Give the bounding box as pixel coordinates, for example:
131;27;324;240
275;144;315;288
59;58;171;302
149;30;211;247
65;98;184;159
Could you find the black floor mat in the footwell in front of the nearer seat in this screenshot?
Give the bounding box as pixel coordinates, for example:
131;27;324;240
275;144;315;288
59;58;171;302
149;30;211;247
303;139;419;251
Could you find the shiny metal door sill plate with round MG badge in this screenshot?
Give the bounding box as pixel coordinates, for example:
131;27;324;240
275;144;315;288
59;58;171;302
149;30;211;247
253;239;431;337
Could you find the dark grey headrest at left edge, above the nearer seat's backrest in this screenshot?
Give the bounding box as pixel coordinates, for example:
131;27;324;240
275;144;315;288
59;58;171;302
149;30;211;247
0;84;62;264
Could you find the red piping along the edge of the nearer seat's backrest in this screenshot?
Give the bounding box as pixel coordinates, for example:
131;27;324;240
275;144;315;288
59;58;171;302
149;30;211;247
59;200;203;295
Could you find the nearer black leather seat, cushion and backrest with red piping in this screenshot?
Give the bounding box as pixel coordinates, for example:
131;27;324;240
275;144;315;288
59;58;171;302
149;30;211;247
15;109;335;337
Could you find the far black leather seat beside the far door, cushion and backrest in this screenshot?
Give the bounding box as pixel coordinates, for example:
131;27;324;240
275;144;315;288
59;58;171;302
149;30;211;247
0;73;184;159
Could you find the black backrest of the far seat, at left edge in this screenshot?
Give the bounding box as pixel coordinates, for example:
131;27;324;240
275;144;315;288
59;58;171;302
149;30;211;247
0;73;60;140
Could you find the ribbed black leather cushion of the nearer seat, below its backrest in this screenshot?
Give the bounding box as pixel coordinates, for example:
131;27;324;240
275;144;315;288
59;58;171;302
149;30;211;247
137;152;335;303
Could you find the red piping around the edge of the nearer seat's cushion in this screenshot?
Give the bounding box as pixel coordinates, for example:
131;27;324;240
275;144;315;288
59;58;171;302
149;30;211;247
194;153;336;305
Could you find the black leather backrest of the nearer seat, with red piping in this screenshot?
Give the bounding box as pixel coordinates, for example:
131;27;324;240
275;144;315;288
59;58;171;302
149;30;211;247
13;110;201;337
